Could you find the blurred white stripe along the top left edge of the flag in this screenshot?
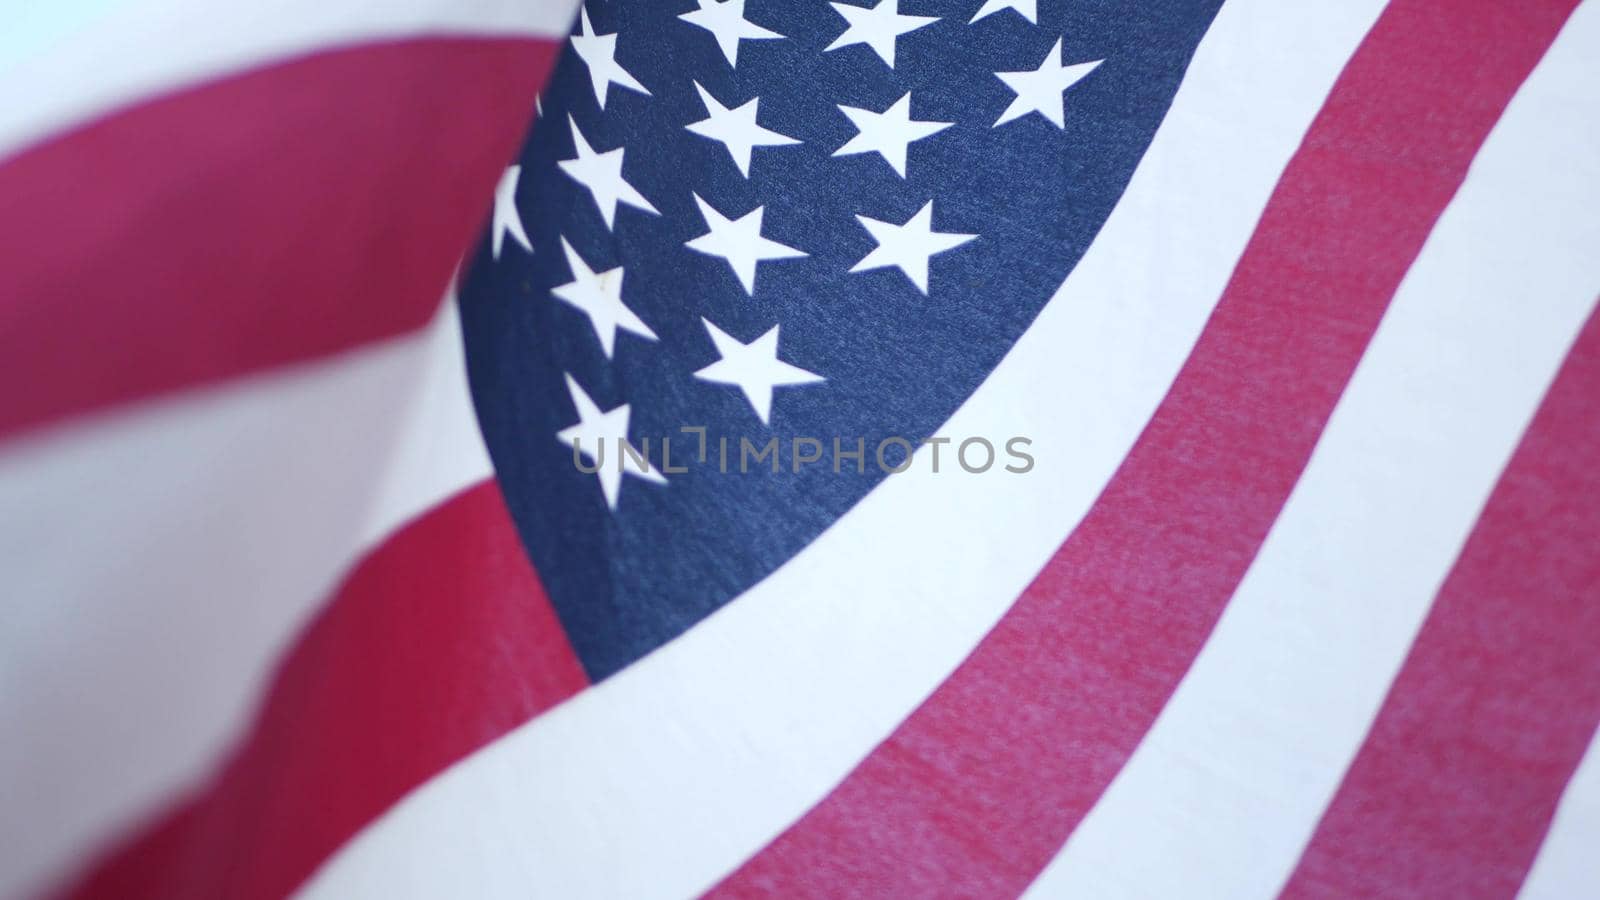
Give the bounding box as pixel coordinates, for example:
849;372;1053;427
0;0;578;162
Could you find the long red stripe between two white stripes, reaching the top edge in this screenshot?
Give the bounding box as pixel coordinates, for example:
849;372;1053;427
712;0;1574;897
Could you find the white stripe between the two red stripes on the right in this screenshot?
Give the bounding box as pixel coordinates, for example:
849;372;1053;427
1032;5;1600;897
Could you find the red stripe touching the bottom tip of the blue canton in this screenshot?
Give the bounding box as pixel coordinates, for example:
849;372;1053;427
62;482;589;900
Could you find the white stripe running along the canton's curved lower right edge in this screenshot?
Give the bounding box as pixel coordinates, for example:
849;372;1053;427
297;0;1381;897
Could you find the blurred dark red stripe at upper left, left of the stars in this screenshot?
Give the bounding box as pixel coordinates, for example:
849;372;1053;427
0;38;558;436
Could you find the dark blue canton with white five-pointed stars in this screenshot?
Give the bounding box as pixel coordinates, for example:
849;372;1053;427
461;0;1221;679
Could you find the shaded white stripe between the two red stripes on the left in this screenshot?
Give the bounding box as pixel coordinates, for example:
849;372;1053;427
0;297;490;895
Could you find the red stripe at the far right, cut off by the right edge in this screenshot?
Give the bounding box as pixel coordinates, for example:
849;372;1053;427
1285;302;1600;897
